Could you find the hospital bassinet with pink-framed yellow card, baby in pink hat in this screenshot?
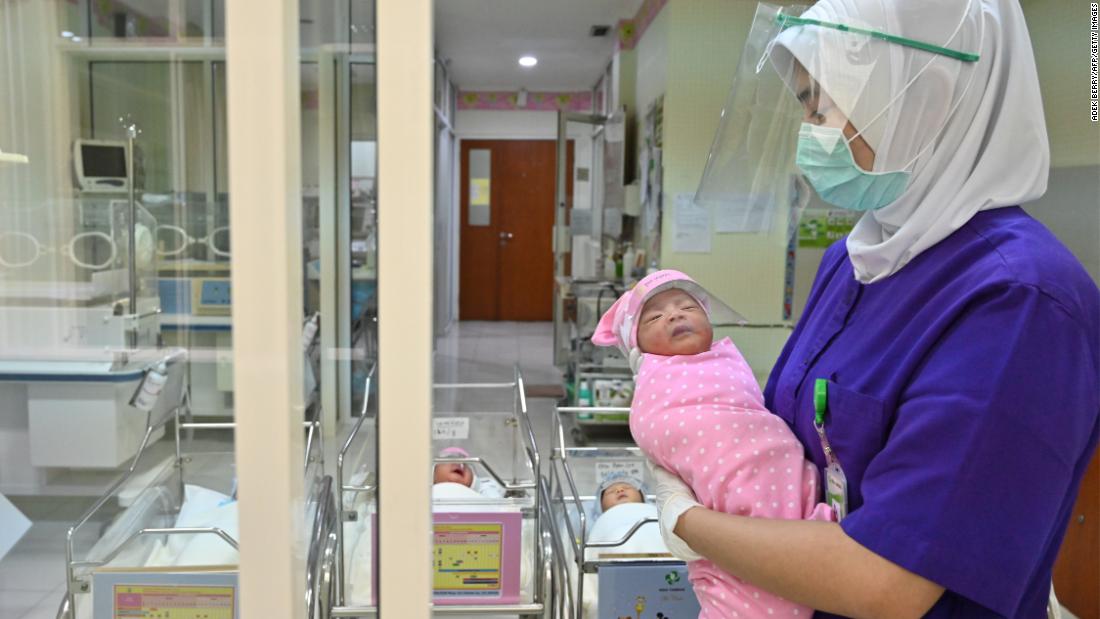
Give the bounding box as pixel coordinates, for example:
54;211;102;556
332;367;561;617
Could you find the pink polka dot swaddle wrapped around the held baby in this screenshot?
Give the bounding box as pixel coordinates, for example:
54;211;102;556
630;338;832;618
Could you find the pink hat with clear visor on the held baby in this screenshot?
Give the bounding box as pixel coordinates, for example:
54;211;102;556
592;268;747;372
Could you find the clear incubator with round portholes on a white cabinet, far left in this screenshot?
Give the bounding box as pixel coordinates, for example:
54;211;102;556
0;193;186;479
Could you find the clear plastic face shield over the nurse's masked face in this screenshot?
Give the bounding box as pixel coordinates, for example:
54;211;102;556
695;0;981;220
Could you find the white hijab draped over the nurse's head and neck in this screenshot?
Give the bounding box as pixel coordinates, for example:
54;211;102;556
777;0;1051;284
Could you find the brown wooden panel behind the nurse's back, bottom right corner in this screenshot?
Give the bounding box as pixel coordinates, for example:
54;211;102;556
1054;454;1100;619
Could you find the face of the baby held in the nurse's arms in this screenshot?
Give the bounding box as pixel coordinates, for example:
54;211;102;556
638;288;714;356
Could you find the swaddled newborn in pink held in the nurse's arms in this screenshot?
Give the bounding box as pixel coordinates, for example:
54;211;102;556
592;270;833;618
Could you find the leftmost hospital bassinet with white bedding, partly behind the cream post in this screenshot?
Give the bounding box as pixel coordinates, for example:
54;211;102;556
57;321;338;619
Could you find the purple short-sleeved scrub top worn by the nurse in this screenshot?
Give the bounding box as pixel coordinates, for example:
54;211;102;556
765;207;1100;618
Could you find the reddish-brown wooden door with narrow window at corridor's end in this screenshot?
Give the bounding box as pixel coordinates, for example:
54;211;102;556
459;140;573;321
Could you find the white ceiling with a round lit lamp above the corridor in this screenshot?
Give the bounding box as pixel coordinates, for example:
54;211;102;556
436;0;642;90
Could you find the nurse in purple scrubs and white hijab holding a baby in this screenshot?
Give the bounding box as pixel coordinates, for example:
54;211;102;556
655;0;1100;618
